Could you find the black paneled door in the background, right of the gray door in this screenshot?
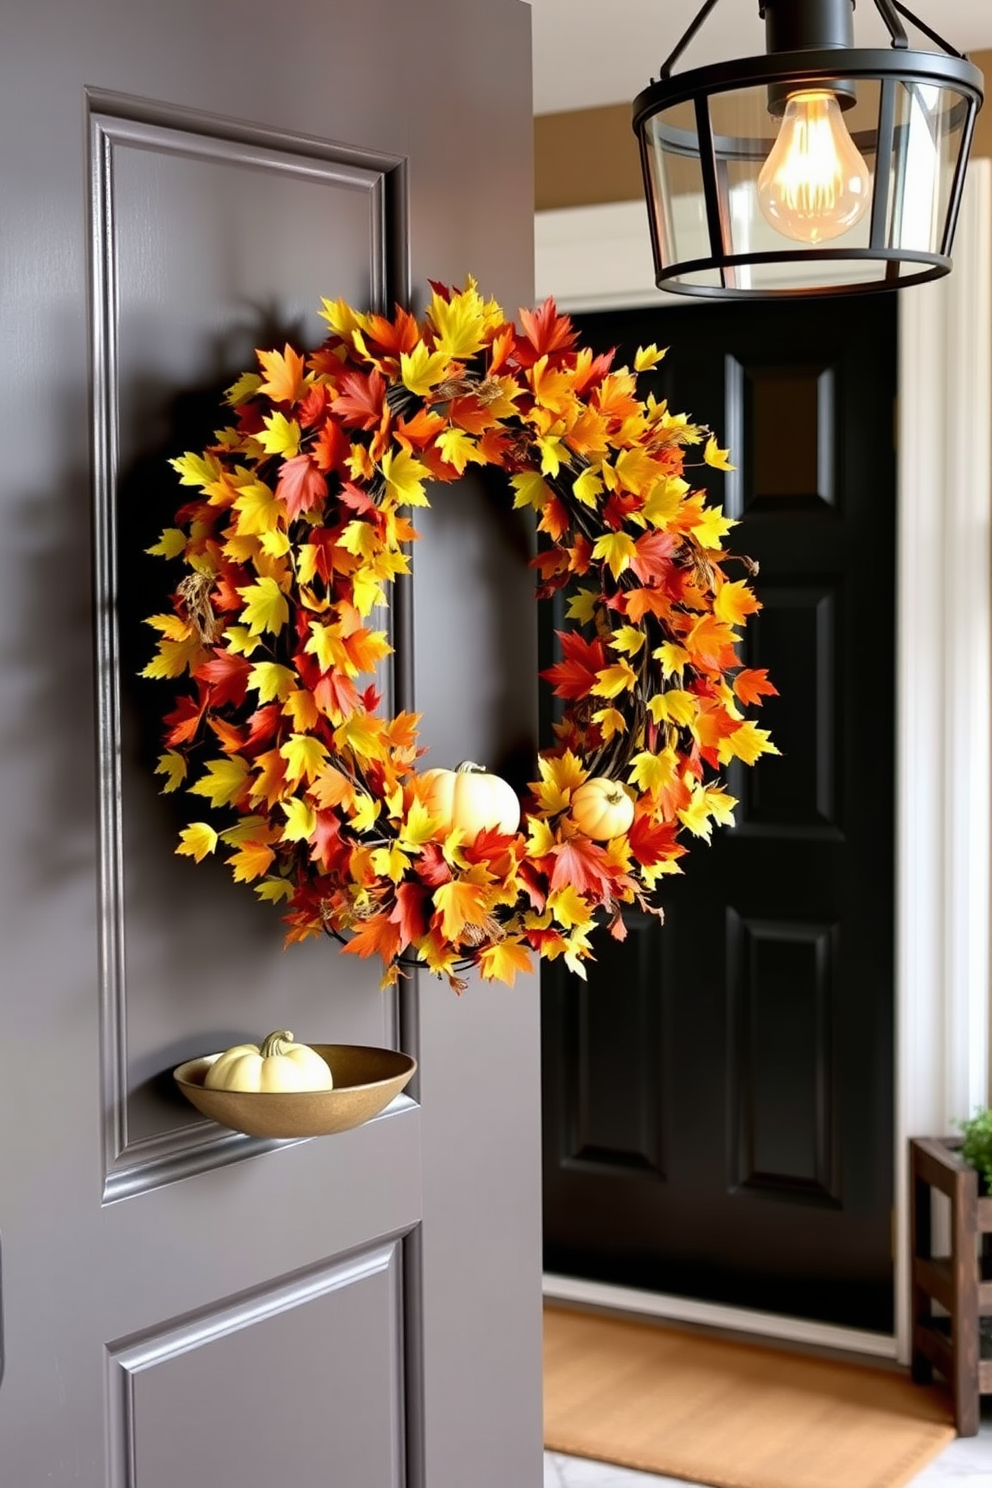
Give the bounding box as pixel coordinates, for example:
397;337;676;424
543;296;897;1332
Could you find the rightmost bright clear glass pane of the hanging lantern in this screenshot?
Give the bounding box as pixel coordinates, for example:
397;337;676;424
888;82;970;253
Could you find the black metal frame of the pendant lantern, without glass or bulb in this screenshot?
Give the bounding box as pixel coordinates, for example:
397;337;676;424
634;0;985;299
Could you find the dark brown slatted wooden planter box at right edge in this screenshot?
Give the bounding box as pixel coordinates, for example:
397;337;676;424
910;1137;992;1436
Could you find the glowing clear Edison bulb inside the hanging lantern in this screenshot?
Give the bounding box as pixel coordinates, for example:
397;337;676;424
759;92;870;243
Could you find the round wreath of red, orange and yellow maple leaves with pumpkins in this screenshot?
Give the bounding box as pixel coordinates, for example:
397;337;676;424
144;280;775;990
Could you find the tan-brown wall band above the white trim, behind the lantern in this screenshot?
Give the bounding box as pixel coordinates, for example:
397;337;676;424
534;52;992;211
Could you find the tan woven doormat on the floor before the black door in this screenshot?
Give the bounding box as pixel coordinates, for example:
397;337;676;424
544;1308;955;1488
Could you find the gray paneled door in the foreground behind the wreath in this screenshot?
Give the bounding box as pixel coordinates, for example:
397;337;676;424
0;0;540;1488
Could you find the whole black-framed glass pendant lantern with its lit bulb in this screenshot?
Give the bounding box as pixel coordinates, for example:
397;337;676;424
634;0;985;299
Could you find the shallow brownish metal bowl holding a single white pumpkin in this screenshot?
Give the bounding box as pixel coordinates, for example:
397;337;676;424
173;1043;416;1137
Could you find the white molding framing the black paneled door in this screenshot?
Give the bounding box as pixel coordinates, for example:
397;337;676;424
535;161;992;1362
